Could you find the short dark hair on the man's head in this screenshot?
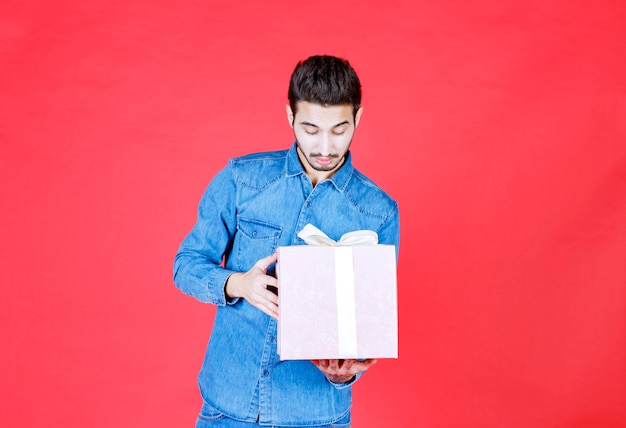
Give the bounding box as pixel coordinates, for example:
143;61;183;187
287;55;361;115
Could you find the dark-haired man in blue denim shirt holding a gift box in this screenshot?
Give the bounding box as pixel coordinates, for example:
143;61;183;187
174;56;399;428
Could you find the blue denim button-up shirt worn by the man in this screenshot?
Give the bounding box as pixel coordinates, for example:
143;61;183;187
174;144;399;426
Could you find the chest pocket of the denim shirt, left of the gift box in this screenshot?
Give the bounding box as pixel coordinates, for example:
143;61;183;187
231;218;282;271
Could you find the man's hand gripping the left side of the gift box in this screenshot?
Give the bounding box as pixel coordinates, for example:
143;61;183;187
225;253;278;319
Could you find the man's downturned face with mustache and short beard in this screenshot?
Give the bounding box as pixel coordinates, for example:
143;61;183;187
287;101;363;185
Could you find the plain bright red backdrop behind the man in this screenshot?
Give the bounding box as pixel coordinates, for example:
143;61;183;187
0;0;626;428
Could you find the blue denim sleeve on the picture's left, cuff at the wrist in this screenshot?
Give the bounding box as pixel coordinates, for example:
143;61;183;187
174;167;237;306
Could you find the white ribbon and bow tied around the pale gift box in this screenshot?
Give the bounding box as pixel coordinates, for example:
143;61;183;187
298;223;378;358
